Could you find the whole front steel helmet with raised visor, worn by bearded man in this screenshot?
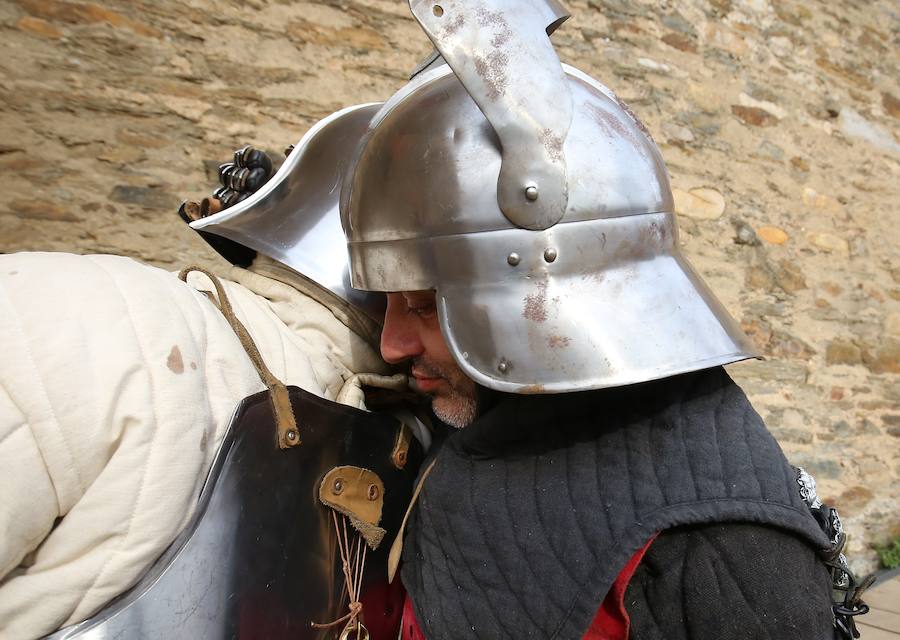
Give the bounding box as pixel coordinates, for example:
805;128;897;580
341;0;755;393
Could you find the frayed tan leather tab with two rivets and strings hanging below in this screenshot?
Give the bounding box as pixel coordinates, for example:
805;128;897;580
319;466;386;549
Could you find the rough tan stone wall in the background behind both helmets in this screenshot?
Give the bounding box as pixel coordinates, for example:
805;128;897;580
0;0;900;568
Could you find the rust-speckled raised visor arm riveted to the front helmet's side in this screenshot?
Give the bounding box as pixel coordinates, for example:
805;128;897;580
409;0;572;229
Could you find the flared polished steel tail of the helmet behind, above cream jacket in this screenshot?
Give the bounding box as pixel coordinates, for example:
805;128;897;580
191;103;384;322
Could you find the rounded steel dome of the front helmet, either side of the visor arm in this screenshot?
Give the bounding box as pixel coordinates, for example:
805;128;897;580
341;66;673;270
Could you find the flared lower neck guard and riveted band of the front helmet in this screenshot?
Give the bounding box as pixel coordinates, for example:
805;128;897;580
429;213;752;393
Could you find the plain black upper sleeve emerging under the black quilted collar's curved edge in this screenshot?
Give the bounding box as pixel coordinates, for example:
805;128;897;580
625;523;834;640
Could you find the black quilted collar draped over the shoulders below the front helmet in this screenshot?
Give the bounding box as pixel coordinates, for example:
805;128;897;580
402;368;828;640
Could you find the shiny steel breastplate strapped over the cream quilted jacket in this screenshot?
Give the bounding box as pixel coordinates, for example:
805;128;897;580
48;387;422;640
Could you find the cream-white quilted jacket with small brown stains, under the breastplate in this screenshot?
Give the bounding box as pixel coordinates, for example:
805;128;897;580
0;253;394;640
